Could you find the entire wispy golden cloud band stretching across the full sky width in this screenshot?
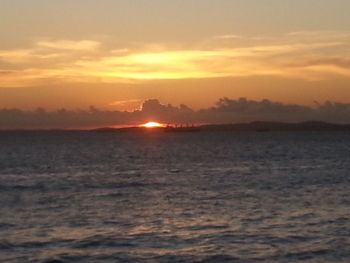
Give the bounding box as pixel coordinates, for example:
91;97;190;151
0;31;350;86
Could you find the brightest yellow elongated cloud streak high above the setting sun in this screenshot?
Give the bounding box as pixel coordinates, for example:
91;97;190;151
72;42;340;82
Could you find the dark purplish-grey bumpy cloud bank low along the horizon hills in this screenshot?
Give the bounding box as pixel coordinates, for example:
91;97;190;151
0;98;350;129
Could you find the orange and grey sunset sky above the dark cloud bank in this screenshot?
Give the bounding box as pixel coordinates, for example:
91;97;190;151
0;0;350;128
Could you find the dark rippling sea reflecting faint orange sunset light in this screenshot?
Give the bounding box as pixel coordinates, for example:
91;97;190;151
0;132;350;263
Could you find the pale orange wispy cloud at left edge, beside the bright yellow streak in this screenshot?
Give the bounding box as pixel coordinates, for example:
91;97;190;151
0;40;100;87
